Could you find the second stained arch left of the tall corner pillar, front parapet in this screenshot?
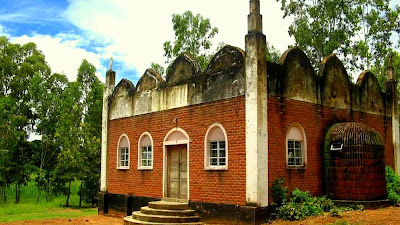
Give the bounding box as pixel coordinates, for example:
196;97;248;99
166;52;200;86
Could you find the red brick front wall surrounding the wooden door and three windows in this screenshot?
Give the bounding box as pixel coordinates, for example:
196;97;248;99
108;96;246;205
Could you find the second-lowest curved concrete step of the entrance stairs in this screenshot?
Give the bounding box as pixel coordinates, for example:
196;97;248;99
132;211;200;224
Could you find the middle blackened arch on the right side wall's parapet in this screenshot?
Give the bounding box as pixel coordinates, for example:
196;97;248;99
319;54;352;109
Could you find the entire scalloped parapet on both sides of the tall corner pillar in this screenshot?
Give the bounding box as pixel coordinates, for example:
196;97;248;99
110;45;392;119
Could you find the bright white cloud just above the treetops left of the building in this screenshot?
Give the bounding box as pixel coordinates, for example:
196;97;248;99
11;33;106;81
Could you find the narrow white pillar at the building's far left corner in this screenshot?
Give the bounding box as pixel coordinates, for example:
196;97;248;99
100;58;115;192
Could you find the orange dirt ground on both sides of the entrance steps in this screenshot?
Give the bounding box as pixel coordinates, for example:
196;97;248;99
0;207;400;225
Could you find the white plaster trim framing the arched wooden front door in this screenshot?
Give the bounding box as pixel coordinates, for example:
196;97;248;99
163;127;190;201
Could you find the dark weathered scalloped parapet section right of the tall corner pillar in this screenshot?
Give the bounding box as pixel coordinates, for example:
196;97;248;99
267;47;391;115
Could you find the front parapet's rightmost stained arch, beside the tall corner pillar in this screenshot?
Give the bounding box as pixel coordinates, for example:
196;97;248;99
206;45;245;76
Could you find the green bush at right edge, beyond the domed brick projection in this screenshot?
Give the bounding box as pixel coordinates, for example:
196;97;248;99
385;166;400;206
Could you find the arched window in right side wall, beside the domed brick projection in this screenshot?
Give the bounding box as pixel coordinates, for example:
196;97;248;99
286;123;307;167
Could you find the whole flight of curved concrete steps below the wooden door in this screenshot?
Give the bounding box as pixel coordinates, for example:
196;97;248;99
124;199;204;225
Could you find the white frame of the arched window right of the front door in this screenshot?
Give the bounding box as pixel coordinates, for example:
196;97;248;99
204;123;229;170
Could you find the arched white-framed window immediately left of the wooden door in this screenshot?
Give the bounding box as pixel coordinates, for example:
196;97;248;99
138;132;153;170
